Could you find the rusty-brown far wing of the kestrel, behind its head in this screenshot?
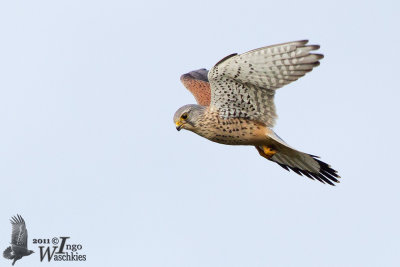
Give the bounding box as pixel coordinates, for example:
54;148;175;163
181;69;211;106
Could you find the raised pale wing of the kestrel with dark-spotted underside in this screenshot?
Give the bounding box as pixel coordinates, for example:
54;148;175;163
208;40;323;127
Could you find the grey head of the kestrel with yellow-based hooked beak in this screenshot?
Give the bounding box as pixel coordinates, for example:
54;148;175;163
174;105;206;132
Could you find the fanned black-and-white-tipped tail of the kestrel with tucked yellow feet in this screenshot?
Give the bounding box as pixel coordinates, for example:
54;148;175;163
256;132;340;185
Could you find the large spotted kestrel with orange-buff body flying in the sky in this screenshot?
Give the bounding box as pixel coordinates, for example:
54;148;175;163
174;40;340;185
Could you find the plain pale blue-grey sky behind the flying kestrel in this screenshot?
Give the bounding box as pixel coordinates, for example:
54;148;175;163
0;0;400;267
